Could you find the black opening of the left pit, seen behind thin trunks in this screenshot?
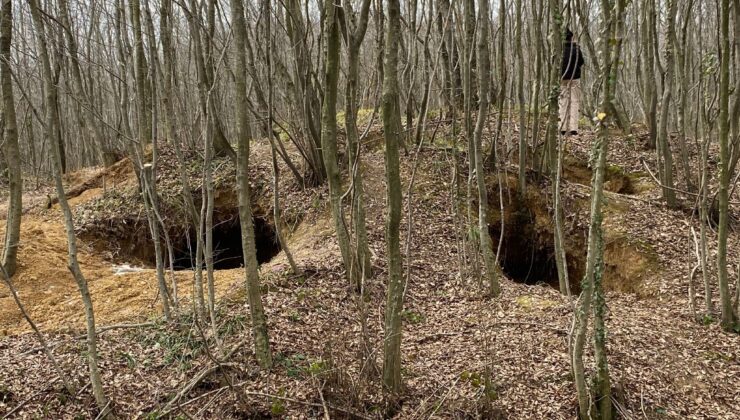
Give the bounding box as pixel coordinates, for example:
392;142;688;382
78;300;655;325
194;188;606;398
168;217;280;270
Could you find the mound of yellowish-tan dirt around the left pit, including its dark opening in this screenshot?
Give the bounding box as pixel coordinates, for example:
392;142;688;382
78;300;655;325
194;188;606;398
0;144;330;335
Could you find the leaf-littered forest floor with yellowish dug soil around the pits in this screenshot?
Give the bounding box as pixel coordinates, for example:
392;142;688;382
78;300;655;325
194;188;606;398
0;123;740;419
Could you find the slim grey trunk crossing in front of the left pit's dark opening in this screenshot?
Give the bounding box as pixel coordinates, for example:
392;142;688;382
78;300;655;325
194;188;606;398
230;0;272;369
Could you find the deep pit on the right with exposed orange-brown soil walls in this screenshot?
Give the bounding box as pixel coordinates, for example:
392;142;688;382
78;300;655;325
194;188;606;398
488;177;657;295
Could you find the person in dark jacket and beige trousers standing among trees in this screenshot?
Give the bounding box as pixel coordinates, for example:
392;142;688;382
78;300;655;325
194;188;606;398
560;29;584;135
